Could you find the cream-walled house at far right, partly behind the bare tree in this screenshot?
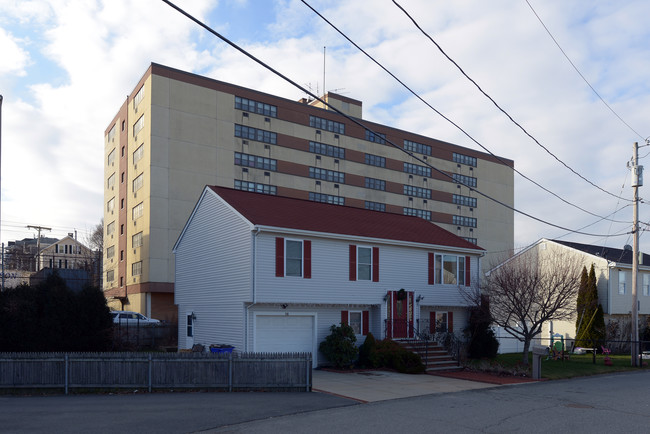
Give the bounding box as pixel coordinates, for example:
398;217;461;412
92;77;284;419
497;238;650;351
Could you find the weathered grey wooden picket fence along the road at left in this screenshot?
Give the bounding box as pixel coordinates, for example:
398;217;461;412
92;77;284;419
0;353;312;394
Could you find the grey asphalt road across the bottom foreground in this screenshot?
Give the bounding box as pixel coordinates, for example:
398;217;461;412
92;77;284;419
0;371;650;434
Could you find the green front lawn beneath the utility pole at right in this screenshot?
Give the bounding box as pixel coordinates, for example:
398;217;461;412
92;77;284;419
469;353;648;380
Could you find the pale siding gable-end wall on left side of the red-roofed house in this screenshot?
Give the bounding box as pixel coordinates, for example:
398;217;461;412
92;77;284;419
174;192;253;351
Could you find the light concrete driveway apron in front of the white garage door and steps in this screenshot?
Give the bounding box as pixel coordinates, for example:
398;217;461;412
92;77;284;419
312;369;495;402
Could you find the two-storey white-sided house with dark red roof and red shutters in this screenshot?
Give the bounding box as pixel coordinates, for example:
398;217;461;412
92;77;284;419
174;187;483;366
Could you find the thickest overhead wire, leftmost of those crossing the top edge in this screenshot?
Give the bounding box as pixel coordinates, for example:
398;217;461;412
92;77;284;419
162;0;628;237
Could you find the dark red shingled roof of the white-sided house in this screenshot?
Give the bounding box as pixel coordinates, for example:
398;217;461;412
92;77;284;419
208;186;483;251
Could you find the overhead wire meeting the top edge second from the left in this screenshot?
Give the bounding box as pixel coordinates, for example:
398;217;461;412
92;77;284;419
301;0;631;223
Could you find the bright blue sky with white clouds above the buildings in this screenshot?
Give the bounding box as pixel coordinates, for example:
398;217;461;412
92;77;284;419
0;0;650;252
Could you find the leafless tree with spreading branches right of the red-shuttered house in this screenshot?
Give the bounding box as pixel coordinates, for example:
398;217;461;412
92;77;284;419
482;252;582;365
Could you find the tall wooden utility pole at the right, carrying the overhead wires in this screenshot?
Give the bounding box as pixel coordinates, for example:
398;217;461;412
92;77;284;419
630;142;643;366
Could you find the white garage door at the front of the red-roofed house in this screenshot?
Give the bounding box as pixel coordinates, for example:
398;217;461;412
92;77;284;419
255;315;316;362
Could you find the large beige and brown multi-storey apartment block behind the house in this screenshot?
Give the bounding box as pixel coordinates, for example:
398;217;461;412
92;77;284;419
104;64;514;321
